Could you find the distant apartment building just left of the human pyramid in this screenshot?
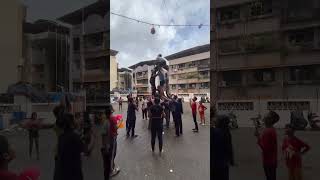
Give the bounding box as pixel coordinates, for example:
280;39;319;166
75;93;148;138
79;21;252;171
129;60;158;96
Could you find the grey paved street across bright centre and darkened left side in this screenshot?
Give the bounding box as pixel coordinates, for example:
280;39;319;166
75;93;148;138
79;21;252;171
5;104;210;180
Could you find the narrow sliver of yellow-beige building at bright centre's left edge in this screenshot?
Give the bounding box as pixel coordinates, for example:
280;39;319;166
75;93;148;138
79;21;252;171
110;49;118;91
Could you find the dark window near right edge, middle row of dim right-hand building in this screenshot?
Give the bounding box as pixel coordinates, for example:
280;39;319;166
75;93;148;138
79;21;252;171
288;29;314;46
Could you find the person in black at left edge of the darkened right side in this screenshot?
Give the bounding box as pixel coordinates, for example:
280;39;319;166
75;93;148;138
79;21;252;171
210;115;234;180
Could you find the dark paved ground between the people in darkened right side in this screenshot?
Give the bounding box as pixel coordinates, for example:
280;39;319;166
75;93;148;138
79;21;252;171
230;128;320;180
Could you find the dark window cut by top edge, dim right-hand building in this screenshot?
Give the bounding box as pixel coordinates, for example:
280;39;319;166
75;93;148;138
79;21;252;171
250;0;272;16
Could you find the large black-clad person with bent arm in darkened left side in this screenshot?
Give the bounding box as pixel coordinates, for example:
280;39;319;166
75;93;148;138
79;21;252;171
57;113;94;180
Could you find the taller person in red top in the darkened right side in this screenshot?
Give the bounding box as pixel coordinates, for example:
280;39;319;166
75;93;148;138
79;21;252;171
255;111;280;180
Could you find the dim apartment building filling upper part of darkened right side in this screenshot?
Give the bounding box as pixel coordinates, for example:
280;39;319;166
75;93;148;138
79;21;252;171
211;0;320;125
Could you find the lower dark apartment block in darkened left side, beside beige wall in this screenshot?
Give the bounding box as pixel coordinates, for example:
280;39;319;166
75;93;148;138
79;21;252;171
22;20;70;92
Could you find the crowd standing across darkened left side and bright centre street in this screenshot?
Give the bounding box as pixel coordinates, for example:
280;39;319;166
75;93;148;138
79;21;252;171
0;96;206;180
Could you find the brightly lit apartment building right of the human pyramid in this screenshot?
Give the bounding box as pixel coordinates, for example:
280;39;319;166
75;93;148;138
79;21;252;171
166;44;210;100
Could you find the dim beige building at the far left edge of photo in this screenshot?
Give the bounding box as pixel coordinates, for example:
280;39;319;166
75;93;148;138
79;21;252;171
0;0;26;94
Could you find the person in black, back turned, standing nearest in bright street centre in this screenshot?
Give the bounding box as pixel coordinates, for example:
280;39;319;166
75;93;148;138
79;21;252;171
150;98;164;154
